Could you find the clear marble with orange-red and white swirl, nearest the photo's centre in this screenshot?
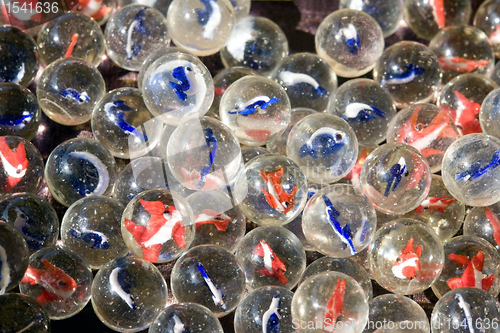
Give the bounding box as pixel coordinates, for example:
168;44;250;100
233;154;307;226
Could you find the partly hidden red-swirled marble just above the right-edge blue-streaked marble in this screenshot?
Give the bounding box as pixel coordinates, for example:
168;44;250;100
437;74;497;135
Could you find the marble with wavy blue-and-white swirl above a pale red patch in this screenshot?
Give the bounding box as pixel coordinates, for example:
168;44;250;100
219;76;291;146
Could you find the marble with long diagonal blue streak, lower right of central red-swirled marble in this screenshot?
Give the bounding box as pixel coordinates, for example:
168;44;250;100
302;184;377;258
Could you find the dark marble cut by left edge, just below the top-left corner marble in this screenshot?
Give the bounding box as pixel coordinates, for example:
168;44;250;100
0;26;39;87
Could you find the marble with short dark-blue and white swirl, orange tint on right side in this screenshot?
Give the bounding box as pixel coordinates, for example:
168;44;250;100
360;143;431;214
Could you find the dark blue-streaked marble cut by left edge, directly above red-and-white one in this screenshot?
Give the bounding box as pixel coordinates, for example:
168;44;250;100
0;83;42;140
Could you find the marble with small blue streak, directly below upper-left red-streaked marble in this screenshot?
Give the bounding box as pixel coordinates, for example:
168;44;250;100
36;56;106;126
